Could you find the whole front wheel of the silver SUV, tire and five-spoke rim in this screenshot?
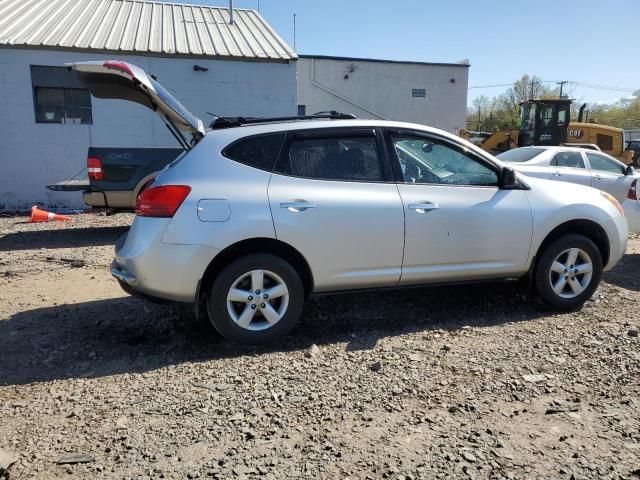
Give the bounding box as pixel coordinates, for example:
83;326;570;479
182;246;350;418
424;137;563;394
535;235;602;311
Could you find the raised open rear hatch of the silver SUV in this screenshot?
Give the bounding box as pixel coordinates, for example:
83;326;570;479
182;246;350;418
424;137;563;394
67;60;205;150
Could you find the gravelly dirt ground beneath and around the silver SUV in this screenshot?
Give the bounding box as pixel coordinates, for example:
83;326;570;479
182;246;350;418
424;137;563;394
0;214;640;479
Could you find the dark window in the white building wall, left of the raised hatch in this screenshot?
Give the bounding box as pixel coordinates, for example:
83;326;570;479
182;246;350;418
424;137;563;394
31;65;93;124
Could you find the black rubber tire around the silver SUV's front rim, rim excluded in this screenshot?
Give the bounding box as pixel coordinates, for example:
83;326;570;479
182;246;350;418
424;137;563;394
534;235;602;311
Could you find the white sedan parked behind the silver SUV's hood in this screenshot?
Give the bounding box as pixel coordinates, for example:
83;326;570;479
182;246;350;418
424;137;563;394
498;146;640;233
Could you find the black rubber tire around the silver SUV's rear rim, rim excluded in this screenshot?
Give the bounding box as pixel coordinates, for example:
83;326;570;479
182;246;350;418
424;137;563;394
208;254;304;345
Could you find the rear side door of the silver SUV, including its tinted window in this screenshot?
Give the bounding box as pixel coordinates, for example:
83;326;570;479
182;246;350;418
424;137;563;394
269;128;404;291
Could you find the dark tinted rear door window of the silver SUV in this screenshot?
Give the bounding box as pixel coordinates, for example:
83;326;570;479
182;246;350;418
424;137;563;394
278;135;383;182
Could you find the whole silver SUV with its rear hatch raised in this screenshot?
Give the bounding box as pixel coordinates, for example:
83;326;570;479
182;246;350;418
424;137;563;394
72;62;627;344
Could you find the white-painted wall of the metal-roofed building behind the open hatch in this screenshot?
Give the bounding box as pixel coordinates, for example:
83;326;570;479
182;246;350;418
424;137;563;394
0;49;296;210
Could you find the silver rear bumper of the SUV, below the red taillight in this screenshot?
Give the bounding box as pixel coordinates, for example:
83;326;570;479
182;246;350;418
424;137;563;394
111;217;218;303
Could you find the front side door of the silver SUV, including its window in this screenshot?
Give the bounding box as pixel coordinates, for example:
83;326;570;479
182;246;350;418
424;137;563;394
387;130;532;284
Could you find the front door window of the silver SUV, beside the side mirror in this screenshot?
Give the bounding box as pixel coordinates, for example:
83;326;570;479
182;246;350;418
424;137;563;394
391;135;498;186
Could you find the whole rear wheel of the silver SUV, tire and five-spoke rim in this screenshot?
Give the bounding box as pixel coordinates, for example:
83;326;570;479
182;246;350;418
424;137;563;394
208;254;304;345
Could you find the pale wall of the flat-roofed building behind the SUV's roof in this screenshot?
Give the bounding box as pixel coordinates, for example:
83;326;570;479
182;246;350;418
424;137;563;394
298;58;469;133
